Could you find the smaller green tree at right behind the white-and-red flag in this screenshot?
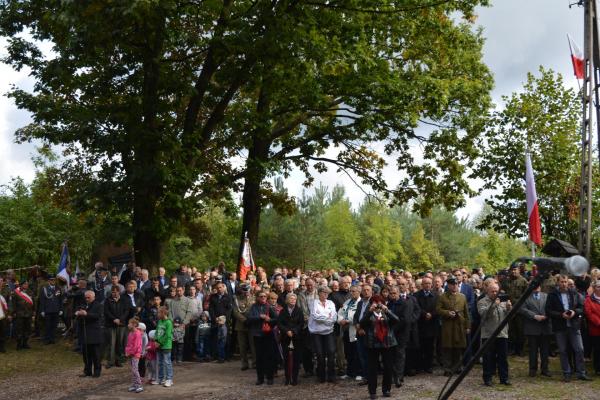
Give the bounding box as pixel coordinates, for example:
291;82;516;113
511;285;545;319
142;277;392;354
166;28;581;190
475;67;584;243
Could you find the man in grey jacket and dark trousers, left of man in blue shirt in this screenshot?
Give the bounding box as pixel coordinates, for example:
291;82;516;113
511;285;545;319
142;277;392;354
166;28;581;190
519;286;552;377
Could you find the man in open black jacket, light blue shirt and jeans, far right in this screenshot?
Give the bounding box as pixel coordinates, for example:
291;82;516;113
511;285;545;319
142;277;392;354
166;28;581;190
546;275;590;382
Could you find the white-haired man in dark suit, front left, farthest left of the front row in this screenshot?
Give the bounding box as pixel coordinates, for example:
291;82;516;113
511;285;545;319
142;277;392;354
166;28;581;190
75;290;104;378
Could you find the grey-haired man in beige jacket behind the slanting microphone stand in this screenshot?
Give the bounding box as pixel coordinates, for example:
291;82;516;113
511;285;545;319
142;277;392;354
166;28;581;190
477;282;512;386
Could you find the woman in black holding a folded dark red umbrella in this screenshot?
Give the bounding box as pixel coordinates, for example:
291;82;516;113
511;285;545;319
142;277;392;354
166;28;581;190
247;291;277;385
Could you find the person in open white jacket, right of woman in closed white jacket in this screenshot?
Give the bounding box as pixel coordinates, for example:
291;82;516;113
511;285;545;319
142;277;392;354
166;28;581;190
338;285;362;381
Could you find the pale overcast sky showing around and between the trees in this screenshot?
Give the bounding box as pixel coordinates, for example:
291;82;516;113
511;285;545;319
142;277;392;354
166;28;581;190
0;0;583;217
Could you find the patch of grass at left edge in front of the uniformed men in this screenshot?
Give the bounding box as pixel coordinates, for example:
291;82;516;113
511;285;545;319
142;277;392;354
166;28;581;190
0;339;82;380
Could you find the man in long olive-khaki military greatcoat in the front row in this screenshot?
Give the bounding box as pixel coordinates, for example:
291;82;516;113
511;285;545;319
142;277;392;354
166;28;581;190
436;277;471;376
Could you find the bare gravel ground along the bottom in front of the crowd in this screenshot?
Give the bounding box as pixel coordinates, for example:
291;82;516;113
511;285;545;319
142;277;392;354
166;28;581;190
0;359;600;400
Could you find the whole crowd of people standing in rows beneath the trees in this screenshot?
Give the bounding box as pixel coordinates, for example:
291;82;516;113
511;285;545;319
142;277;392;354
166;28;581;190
0;262;600;398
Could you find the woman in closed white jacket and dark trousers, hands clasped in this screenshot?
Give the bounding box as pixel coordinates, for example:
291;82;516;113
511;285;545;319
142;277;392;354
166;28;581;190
308;286;337;383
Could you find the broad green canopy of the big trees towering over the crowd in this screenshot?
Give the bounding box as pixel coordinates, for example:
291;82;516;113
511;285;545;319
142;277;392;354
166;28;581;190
0;0;492;267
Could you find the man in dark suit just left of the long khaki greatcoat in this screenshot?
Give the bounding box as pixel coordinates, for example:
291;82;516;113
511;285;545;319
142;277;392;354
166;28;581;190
415;277;439;374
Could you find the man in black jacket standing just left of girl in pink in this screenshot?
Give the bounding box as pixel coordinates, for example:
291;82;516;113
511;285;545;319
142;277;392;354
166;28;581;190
104;286;131;368
